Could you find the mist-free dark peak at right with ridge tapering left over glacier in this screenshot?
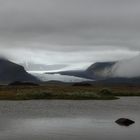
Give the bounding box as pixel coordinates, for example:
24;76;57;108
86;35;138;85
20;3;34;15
46;62;117;80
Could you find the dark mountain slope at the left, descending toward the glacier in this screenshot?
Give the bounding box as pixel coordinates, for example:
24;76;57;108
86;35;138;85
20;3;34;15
0;58;39;84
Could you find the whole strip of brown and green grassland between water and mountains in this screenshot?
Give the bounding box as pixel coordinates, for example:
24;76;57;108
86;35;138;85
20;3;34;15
0;85;140;100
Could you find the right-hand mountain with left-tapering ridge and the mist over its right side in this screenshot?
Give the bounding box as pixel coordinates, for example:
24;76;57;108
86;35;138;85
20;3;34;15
46;56;140;81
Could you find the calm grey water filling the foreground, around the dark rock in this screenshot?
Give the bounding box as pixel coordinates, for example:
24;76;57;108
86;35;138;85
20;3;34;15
0;97;140;140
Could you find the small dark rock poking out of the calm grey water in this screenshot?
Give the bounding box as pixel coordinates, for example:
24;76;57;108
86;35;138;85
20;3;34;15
115;118;135;126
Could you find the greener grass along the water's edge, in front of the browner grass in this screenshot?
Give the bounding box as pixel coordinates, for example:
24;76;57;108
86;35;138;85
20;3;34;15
16;92;117;100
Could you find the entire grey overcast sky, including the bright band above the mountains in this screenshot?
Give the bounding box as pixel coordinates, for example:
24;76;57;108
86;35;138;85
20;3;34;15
0;0;140;67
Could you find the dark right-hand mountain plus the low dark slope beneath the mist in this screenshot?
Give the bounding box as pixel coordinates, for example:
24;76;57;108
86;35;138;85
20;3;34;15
44;61;140;86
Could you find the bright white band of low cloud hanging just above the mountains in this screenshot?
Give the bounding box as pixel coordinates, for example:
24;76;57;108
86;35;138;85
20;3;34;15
0;46;139;69
